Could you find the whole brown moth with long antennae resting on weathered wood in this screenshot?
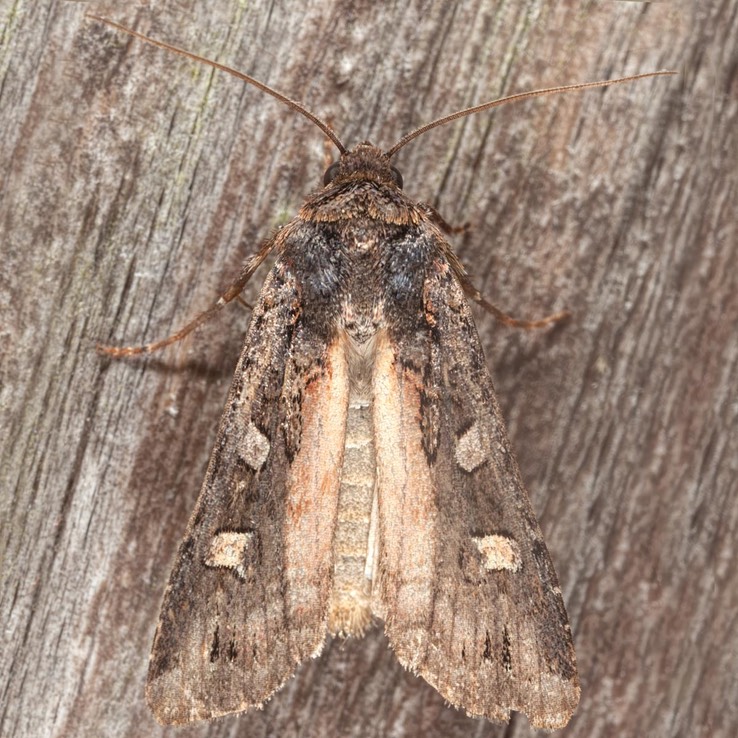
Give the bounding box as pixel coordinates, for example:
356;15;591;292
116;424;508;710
92;16;662;730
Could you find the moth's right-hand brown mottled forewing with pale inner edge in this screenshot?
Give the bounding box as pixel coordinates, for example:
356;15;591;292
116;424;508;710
374;235;579;729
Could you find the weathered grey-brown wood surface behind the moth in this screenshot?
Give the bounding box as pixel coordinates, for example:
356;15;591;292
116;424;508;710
0;0;738;738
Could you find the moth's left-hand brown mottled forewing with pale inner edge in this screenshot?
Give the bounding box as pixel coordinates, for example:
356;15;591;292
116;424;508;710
147;250;348;724
